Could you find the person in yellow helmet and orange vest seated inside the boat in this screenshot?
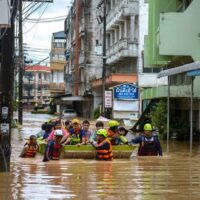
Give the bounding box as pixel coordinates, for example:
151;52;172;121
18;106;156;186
108;120;120;145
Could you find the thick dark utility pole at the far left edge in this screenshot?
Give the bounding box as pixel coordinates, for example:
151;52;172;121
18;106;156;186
0;0;17;172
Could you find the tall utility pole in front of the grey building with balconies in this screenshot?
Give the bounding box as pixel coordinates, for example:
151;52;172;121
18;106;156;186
102;0;107;116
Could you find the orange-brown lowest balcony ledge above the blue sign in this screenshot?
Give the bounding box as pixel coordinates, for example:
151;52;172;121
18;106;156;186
91;73;138;88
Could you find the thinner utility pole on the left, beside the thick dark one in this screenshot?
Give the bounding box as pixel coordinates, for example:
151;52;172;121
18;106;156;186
18;0;24;124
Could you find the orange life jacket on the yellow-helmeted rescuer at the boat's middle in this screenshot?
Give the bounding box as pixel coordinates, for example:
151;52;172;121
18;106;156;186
97;139;113;160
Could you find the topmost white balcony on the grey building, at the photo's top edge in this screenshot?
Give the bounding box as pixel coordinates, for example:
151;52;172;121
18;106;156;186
106;0;139;30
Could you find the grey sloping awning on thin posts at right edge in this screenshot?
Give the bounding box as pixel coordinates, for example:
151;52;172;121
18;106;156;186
158;61;200;78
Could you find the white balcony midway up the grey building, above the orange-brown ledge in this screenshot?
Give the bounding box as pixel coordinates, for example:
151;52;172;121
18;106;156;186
106;39;138;64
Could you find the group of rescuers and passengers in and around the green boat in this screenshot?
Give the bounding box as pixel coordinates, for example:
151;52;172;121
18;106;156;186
20;119;162;162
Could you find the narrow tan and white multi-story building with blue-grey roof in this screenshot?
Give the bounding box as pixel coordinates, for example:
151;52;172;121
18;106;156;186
50;31;66;95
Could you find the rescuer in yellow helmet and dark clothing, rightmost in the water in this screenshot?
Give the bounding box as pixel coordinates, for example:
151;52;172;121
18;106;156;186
130;123;162;156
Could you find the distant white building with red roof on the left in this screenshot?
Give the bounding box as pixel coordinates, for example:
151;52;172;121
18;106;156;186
23;65;51;106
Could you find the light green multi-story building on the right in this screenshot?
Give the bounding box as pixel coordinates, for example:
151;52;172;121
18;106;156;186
142;0;200;132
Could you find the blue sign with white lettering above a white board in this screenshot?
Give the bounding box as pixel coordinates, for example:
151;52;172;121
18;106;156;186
114;83;138;100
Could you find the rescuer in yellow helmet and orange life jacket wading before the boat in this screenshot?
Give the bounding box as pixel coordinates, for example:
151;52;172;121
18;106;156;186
90;129;113;160
